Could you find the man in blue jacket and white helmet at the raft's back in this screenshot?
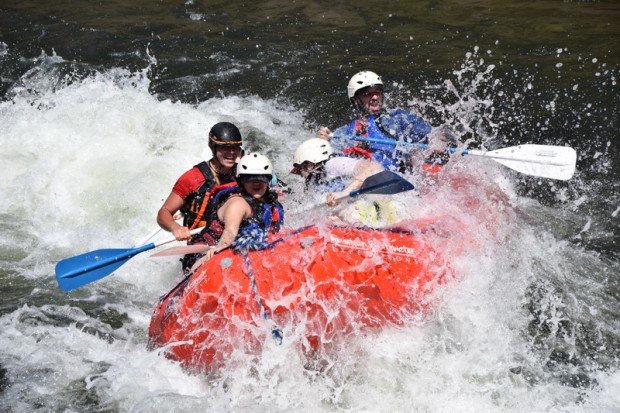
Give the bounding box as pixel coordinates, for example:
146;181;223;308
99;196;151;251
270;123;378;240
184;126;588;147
317;71;456;172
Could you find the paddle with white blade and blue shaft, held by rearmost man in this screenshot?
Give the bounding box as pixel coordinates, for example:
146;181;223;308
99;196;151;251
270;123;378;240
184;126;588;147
351;137;577;181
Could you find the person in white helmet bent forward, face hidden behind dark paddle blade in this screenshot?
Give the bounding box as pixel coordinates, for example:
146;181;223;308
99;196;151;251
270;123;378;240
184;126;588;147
290;138;402;227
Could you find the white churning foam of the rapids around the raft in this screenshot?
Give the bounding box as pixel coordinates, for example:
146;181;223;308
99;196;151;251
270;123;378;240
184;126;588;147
0;55;619;412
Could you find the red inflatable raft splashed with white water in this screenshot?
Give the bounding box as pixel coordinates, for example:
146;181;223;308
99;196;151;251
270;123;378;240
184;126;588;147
149;221;449;371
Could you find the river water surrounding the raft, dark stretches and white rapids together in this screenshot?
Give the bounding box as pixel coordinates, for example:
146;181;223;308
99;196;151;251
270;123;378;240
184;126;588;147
0;0;620;412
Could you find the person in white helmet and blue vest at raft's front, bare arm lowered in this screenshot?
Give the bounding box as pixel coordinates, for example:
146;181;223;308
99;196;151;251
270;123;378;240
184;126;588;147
194;152;284;267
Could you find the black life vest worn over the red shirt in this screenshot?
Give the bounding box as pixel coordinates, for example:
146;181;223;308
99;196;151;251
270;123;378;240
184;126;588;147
181;161;234;229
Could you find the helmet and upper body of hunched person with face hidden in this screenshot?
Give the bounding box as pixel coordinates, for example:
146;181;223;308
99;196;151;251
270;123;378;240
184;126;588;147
291;138;383;205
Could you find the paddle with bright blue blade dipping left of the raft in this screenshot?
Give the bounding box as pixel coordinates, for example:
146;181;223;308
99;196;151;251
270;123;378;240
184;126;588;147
56;228;202;291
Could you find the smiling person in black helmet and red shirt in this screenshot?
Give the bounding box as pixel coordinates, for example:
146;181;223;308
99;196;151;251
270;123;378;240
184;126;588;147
157;122;243;271
